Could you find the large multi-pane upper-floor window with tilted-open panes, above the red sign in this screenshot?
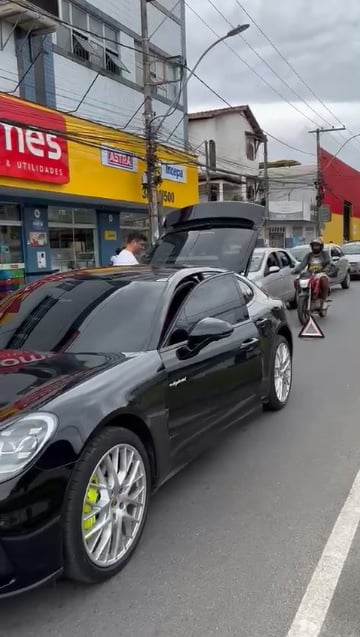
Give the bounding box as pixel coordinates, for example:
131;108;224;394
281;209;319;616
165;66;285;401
56;0;127;76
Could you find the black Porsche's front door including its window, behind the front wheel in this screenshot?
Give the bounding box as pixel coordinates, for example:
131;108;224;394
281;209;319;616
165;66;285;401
160;273;262;466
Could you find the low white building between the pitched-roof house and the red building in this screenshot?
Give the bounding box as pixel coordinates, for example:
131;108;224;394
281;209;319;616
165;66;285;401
262;162;317;247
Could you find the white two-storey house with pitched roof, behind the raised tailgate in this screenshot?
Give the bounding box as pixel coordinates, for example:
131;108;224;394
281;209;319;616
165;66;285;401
189;106;264;201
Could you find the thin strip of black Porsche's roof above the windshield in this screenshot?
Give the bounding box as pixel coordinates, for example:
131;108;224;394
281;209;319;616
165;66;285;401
30;265;226;285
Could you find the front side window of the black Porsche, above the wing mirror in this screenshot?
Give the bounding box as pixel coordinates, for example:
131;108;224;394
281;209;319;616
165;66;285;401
167;273;248;345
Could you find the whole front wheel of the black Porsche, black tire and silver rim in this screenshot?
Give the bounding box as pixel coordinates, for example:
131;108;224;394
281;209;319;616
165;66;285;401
63;427;151;584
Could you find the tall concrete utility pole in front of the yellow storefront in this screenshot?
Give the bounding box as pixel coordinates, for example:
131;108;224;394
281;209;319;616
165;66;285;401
140;0;159;244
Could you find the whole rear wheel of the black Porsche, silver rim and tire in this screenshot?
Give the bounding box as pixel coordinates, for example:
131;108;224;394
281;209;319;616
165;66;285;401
264;336;292;411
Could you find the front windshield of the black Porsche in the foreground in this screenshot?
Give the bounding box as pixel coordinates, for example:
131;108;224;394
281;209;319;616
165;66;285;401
0;274;165;354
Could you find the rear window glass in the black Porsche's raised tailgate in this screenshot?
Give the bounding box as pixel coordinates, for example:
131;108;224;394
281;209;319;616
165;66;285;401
149;228;254;272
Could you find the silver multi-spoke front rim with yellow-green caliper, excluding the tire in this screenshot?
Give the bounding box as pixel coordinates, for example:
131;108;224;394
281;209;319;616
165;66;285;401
82;444;148;568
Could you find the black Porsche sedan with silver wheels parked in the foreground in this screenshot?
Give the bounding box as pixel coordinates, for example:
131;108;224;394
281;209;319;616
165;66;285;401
0;201;293;597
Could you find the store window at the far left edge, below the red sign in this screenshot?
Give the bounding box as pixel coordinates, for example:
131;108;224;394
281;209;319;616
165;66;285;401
0;204;24;264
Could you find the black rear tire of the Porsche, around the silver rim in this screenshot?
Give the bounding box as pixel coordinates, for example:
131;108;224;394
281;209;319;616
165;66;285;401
264;335;292;411
